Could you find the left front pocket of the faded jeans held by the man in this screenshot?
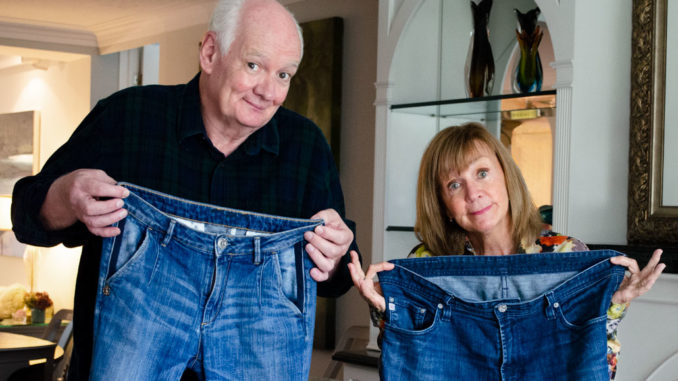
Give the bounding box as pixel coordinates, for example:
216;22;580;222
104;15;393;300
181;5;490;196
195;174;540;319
106;217;159;283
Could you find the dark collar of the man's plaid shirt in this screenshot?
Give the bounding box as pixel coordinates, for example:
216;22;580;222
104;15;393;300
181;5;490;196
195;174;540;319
177;73;280;156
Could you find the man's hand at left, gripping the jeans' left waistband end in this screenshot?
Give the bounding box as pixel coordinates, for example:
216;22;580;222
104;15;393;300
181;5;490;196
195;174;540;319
40;169;129;237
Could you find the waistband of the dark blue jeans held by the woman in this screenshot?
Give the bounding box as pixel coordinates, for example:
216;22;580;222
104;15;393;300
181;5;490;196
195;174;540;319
379;250;625;313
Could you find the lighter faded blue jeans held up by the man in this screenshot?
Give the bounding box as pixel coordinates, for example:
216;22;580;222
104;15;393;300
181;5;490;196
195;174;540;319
90;183;322;381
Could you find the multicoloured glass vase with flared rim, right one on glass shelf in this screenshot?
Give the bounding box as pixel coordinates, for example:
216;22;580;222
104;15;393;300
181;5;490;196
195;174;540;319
513;7;544;94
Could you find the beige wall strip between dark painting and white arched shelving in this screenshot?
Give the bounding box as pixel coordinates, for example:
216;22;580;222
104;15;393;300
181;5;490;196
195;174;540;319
288;0;378;339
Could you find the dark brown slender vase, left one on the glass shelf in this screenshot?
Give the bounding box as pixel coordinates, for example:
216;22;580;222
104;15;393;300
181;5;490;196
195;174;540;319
466;0;494;98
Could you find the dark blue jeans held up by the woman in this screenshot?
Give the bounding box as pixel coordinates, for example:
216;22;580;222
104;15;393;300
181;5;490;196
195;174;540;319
379;250;624;380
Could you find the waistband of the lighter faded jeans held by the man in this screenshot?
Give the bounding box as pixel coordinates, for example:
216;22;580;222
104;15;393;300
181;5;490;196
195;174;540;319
118;182;323;254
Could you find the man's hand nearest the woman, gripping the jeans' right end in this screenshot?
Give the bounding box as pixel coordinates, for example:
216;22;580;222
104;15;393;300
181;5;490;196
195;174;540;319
304;209;353;282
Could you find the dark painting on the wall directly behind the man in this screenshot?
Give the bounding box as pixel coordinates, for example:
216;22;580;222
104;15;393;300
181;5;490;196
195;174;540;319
283;17;344;349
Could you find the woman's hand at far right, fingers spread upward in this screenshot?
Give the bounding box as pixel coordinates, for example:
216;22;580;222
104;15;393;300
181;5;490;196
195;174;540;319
610;249;666;304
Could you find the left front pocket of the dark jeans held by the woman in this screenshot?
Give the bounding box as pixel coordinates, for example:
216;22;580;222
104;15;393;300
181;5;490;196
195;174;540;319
385;297;440;334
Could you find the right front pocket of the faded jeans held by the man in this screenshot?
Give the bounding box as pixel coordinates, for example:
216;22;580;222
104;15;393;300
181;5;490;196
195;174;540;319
273;245;305;315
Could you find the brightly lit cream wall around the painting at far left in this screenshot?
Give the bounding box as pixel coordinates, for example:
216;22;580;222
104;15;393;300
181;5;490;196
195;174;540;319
0;56;90;309
